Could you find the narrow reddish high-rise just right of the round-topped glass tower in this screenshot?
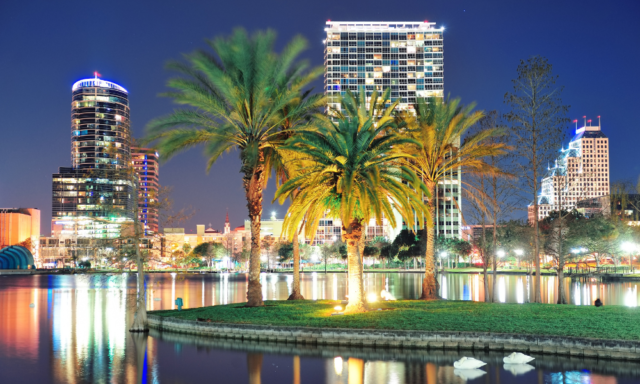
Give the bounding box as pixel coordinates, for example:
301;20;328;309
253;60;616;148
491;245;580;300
131;147;160;235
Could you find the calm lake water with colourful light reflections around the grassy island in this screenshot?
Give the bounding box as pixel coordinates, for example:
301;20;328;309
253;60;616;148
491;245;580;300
0;273;640;384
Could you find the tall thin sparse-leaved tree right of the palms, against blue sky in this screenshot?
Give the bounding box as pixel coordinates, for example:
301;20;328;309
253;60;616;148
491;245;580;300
504;56;569;303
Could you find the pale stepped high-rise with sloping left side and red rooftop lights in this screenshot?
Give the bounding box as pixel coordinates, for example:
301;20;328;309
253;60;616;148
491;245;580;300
528;116;610;222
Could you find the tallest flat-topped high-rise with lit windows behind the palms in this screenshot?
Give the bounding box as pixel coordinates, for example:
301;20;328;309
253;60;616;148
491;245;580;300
324;21;462;237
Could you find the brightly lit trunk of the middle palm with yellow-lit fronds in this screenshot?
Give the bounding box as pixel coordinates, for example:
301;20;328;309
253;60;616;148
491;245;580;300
342;219;367;313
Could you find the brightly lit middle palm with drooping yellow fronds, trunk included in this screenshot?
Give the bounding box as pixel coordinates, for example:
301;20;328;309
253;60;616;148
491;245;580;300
276;89;428;313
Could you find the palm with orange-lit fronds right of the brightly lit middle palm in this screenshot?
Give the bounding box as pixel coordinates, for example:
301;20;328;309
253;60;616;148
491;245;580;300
400;98;508;300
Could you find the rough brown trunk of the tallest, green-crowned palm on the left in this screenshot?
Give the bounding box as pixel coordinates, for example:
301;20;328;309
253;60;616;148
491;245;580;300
242;158;264;307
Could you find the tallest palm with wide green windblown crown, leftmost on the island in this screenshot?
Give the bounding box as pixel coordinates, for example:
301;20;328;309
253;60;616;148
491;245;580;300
145;29;321;307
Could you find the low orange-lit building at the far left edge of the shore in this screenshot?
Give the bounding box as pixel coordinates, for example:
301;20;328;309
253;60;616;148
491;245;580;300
0;208;40;263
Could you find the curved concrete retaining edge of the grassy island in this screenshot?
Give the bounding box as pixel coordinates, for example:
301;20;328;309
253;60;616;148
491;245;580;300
148;314;640;361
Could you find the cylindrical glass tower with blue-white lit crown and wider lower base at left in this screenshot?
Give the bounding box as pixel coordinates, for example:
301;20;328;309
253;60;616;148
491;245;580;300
51;77;136;238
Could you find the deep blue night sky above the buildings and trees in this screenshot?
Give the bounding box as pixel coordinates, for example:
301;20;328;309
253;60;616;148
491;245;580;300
0;0;640;235
